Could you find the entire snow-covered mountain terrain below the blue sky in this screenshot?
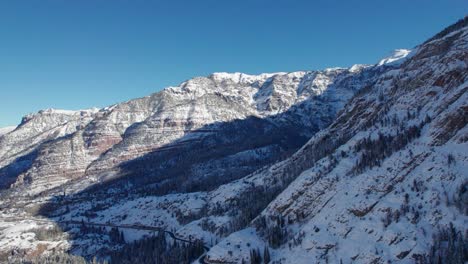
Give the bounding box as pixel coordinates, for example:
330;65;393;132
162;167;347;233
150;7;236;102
0;18;468;263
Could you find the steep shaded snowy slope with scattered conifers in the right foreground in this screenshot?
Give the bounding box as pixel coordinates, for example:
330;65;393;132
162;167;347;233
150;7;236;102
205;19;468;263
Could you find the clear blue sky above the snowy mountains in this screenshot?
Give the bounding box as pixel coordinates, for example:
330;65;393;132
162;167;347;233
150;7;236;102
0;0;468;127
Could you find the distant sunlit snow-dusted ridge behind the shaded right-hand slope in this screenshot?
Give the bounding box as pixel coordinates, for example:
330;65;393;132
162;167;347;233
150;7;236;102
0;63;388;195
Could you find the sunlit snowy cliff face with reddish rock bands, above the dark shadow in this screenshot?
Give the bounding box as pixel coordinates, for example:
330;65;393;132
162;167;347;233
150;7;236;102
0;66;371;194
